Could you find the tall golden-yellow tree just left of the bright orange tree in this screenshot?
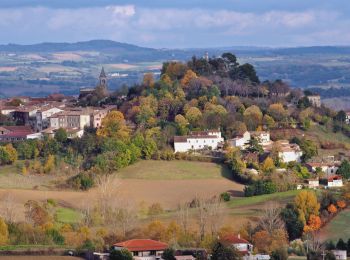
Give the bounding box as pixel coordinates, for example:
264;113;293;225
294;190;320;224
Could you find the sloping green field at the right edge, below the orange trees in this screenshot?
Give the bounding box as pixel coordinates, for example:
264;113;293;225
321;209;350;241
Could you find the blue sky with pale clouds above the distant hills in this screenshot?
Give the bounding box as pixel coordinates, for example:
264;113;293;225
0;0;350;48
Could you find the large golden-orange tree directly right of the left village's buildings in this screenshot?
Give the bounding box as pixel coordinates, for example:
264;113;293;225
97;111;130;141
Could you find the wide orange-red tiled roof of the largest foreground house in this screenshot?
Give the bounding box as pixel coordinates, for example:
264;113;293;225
114;239;168;252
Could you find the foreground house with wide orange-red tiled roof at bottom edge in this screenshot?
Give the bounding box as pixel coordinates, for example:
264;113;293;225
113;239;168;260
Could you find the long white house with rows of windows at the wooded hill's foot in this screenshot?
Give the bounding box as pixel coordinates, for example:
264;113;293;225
174;130;224;153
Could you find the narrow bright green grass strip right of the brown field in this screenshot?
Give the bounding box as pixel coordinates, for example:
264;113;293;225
227;190;299;208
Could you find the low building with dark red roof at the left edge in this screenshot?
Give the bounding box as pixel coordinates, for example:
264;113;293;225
0;126;33;142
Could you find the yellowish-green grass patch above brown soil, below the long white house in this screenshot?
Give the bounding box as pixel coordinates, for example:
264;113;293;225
117;161;230;180
